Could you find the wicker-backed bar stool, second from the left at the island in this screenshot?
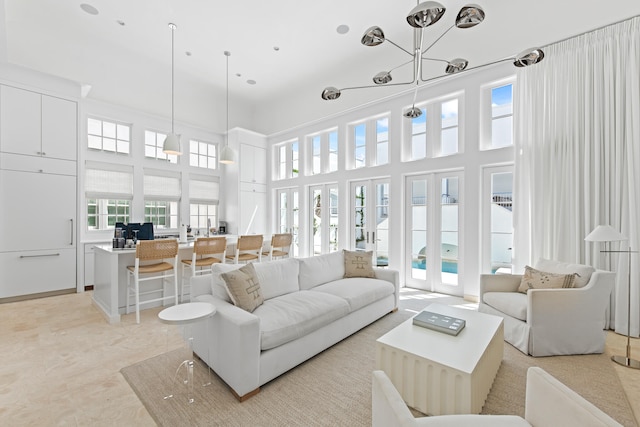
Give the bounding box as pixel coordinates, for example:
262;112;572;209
180;237;227;302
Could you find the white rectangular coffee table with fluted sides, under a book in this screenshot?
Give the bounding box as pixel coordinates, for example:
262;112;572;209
376;303;504;415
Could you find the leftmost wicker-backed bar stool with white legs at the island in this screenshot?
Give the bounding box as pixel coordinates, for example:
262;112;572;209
126;239;178;323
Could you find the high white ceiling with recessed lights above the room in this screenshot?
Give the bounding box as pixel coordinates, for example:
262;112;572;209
0;0;640;133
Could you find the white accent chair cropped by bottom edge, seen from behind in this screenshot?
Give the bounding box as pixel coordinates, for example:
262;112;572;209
371;367;622;427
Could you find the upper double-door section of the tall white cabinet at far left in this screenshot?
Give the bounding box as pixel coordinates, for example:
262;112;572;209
0;85;77;160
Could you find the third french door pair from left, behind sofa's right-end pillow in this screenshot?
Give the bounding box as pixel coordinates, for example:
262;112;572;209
350;178;390;267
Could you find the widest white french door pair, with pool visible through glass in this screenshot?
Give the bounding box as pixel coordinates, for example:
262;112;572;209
405;172;464;296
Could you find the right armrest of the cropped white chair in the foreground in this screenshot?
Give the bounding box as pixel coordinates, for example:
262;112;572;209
524;367;621;427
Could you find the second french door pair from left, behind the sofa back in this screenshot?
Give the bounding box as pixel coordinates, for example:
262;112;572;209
309;184;338;255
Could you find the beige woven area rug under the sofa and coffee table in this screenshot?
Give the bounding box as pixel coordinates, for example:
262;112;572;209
121;310;636;426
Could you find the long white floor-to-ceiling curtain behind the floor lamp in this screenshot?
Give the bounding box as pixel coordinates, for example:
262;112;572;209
514;17;640;336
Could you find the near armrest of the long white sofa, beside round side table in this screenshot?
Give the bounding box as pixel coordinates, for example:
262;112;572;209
193;295;260;397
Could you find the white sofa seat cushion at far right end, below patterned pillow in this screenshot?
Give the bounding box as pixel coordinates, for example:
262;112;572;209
312;277;395;312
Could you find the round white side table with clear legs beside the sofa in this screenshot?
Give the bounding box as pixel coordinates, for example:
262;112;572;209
158;302;216;403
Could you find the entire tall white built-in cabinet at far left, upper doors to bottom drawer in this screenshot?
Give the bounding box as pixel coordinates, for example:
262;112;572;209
0;85;78;300
